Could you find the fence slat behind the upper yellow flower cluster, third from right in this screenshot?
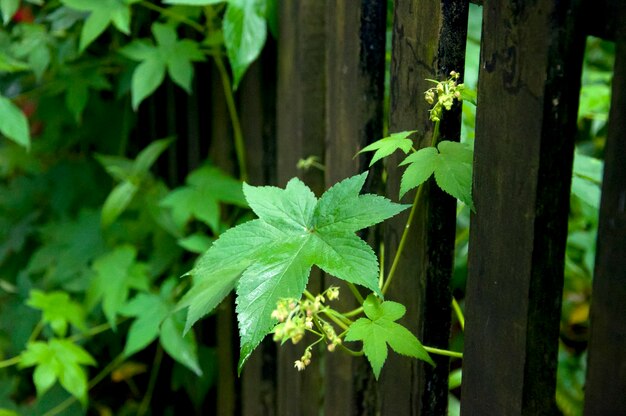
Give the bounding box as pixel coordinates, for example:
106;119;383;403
380;0;468;415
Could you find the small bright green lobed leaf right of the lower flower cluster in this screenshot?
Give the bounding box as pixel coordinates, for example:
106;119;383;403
346;294;435;379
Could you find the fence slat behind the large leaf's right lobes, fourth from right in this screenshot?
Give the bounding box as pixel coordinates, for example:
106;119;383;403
324;0;387;416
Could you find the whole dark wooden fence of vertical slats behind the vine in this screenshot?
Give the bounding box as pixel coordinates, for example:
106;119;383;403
144;0;626;416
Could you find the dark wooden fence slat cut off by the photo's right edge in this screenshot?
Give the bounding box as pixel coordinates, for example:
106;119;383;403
585;38;626;416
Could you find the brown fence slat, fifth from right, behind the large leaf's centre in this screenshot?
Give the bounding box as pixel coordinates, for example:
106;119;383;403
276;0;326;416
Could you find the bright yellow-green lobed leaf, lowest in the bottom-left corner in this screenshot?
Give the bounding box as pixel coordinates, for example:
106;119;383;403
20;338;96;405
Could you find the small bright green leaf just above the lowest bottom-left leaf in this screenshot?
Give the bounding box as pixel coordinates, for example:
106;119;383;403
26;290;87;336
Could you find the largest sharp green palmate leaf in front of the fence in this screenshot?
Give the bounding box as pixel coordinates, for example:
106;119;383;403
180;173;408;369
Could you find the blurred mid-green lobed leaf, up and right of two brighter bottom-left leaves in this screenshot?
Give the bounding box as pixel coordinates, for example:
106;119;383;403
87;245;149;330
